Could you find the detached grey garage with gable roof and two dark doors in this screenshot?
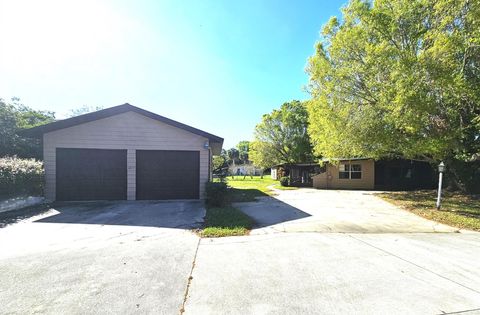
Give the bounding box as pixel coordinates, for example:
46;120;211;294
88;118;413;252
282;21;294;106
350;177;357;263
22;104;223;200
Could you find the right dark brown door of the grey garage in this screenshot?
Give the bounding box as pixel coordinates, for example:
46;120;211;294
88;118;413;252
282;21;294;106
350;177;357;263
136;150;200;200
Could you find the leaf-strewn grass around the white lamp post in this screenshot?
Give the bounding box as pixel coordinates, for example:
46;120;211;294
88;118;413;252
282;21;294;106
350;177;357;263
377;190;480;231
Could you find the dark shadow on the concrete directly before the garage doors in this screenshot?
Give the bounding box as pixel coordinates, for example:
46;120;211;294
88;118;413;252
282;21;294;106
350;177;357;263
35;200;205;229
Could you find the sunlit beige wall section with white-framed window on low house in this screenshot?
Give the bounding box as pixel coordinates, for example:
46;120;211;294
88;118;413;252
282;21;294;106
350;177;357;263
312;158;375;189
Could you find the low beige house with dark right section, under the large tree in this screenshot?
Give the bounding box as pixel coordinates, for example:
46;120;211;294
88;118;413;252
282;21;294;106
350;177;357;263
312;158;435;190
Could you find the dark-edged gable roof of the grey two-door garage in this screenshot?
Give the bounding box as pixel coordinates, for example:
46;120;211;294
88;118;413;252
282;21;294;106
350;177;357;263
19;103;223;151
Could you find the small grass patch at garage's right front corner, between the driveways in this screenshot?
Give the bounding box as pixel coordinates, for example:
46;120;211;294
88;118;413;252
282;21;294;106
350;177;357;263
200;206;253;237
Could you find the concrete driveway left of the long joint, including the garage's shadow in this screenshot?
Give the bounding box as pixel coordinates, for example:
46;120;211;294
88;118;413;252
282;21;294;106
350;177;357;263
0;202;205;314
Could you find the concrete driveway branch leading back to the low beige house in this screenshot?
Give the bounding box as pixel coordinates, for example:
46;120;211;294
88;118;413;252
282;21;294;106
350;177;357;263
235;188;457;234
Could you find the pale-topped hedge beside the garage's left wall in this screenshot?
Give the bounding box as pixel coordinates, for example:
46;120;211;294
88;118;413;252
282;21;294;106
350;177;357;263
0;156;44;198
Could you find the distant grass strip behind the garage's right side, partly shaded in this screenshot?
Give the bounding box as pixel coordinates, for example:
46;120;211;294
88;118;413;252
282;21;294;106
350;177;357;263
226;175;298;202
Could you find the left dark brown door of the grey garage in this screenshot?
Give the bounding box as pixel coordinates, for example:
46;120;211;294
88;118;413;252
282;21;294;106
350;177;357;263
56;148;127;200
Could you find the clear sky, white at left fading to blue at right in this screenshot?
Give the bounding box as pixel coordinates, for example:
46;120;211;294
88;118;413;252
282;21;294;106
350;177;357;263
0;0;345;148
